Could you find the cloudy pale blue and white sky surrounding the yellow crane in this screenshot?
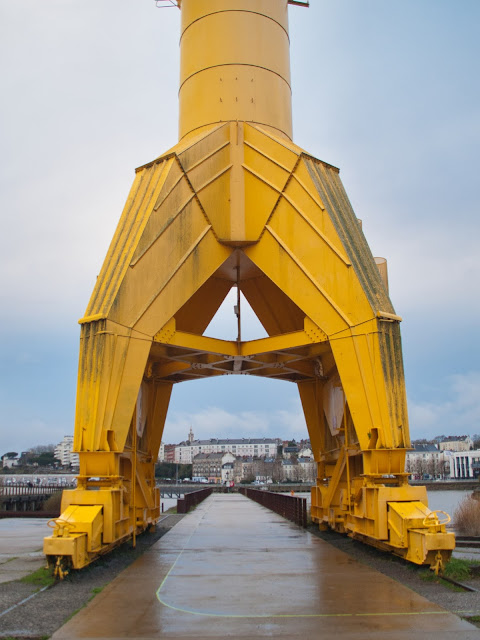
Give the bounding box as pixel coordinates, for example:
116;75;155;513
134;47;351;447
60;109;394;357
0;0;480;455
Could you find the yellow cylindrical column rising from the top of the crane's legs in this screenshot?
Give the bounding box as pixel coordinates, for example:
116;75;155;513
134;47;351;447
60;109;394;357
179;0;292;141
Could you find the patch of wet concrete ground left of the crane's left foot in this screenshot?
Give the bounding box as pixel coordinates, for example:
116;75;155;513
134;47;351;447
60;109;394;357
0;518;50;583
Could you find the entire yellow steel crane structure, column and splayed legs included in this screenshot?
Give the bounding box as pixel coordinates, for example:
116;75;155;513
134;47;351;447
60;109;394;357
45;0;454;568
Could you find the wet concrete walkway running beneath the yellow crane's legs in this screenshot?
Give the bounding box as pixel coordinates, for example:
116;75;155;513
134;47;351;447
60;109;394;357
48;494;480;640
